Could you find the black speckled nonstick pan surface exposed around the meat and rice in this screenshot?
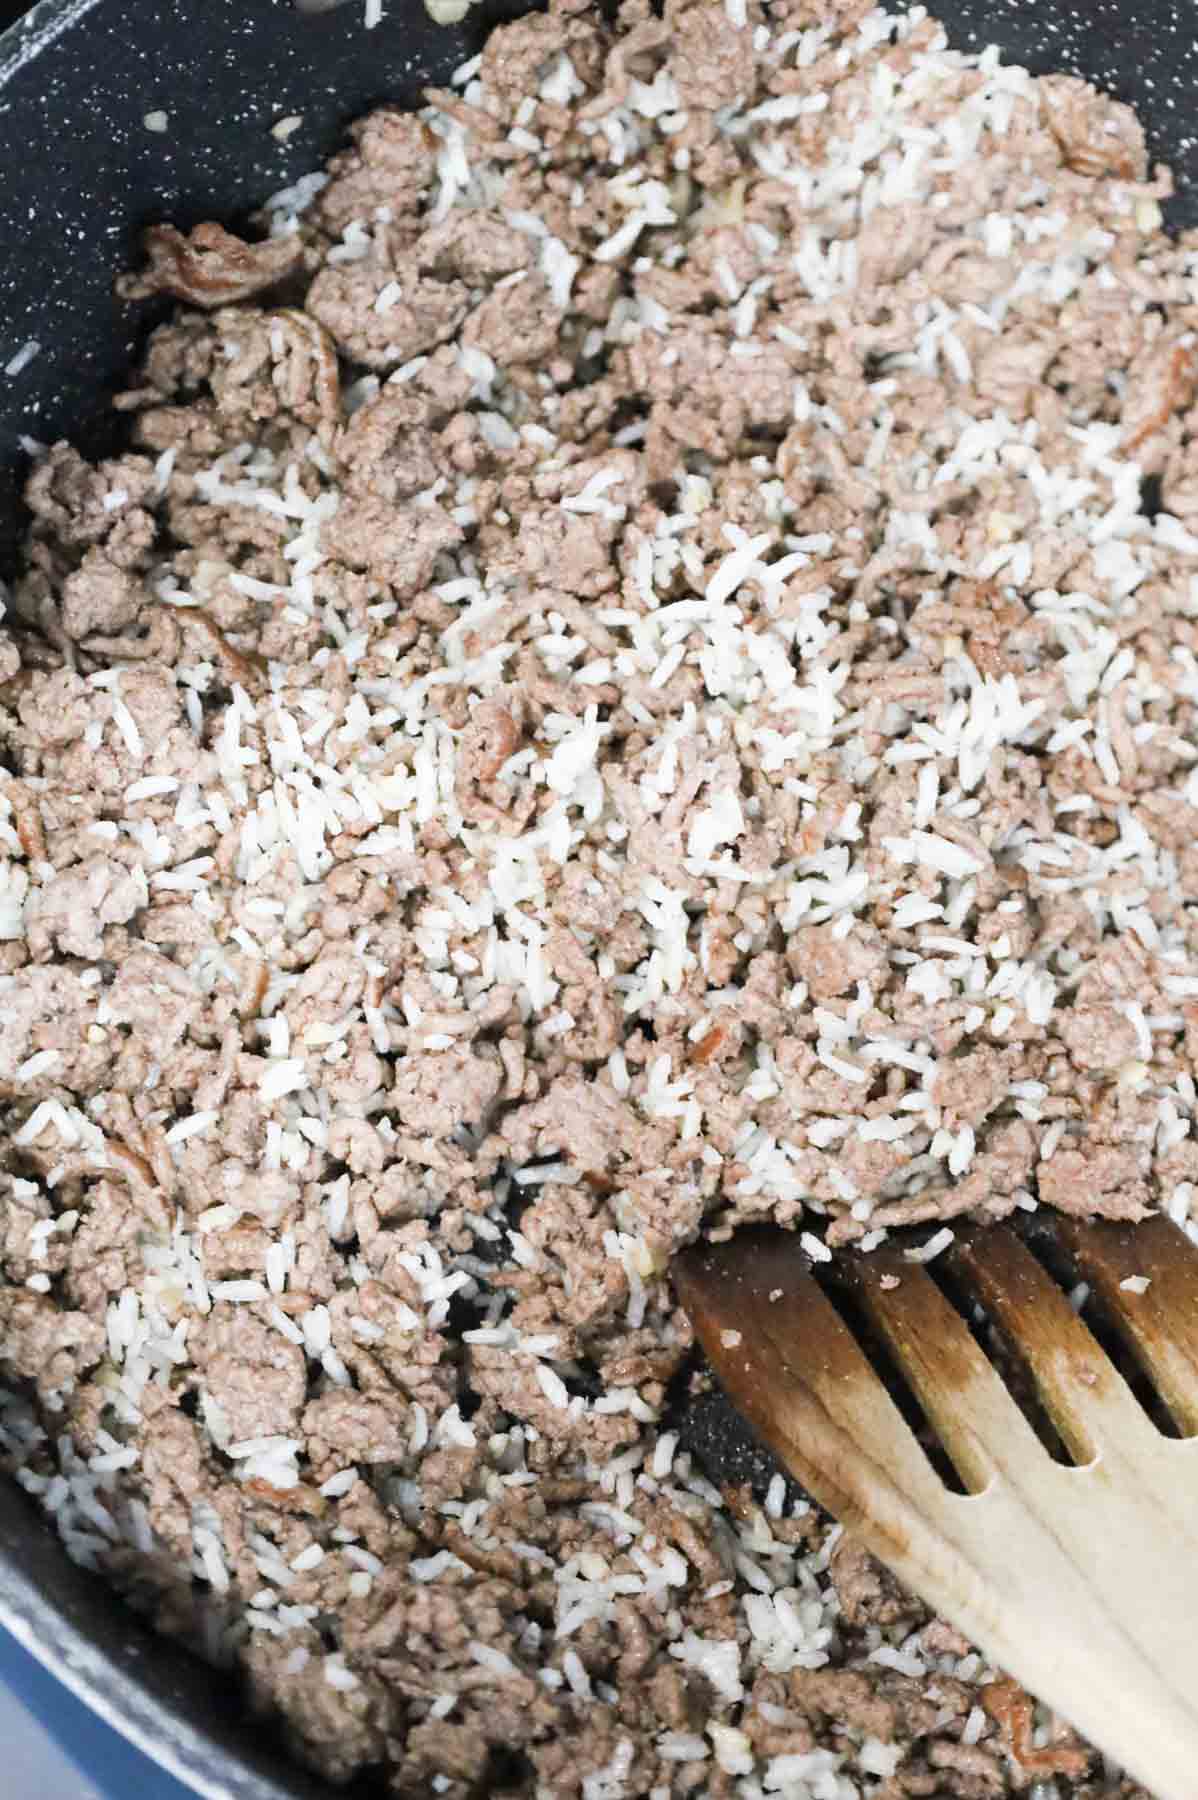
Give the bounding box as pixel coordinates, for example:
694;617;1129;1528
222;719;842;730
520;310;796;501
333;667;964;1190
0;0;1198;1800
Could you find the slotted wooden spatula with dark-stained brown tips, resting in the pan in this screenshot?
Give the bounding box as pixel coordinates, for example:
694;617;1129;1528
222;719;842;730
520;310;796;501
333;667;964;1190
676;1219;1198;1800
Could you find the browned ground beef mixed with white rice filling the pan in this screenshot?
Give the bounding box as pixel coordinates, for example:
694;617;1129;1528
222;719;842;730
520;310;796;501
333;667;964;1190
0;0;1198;1800
